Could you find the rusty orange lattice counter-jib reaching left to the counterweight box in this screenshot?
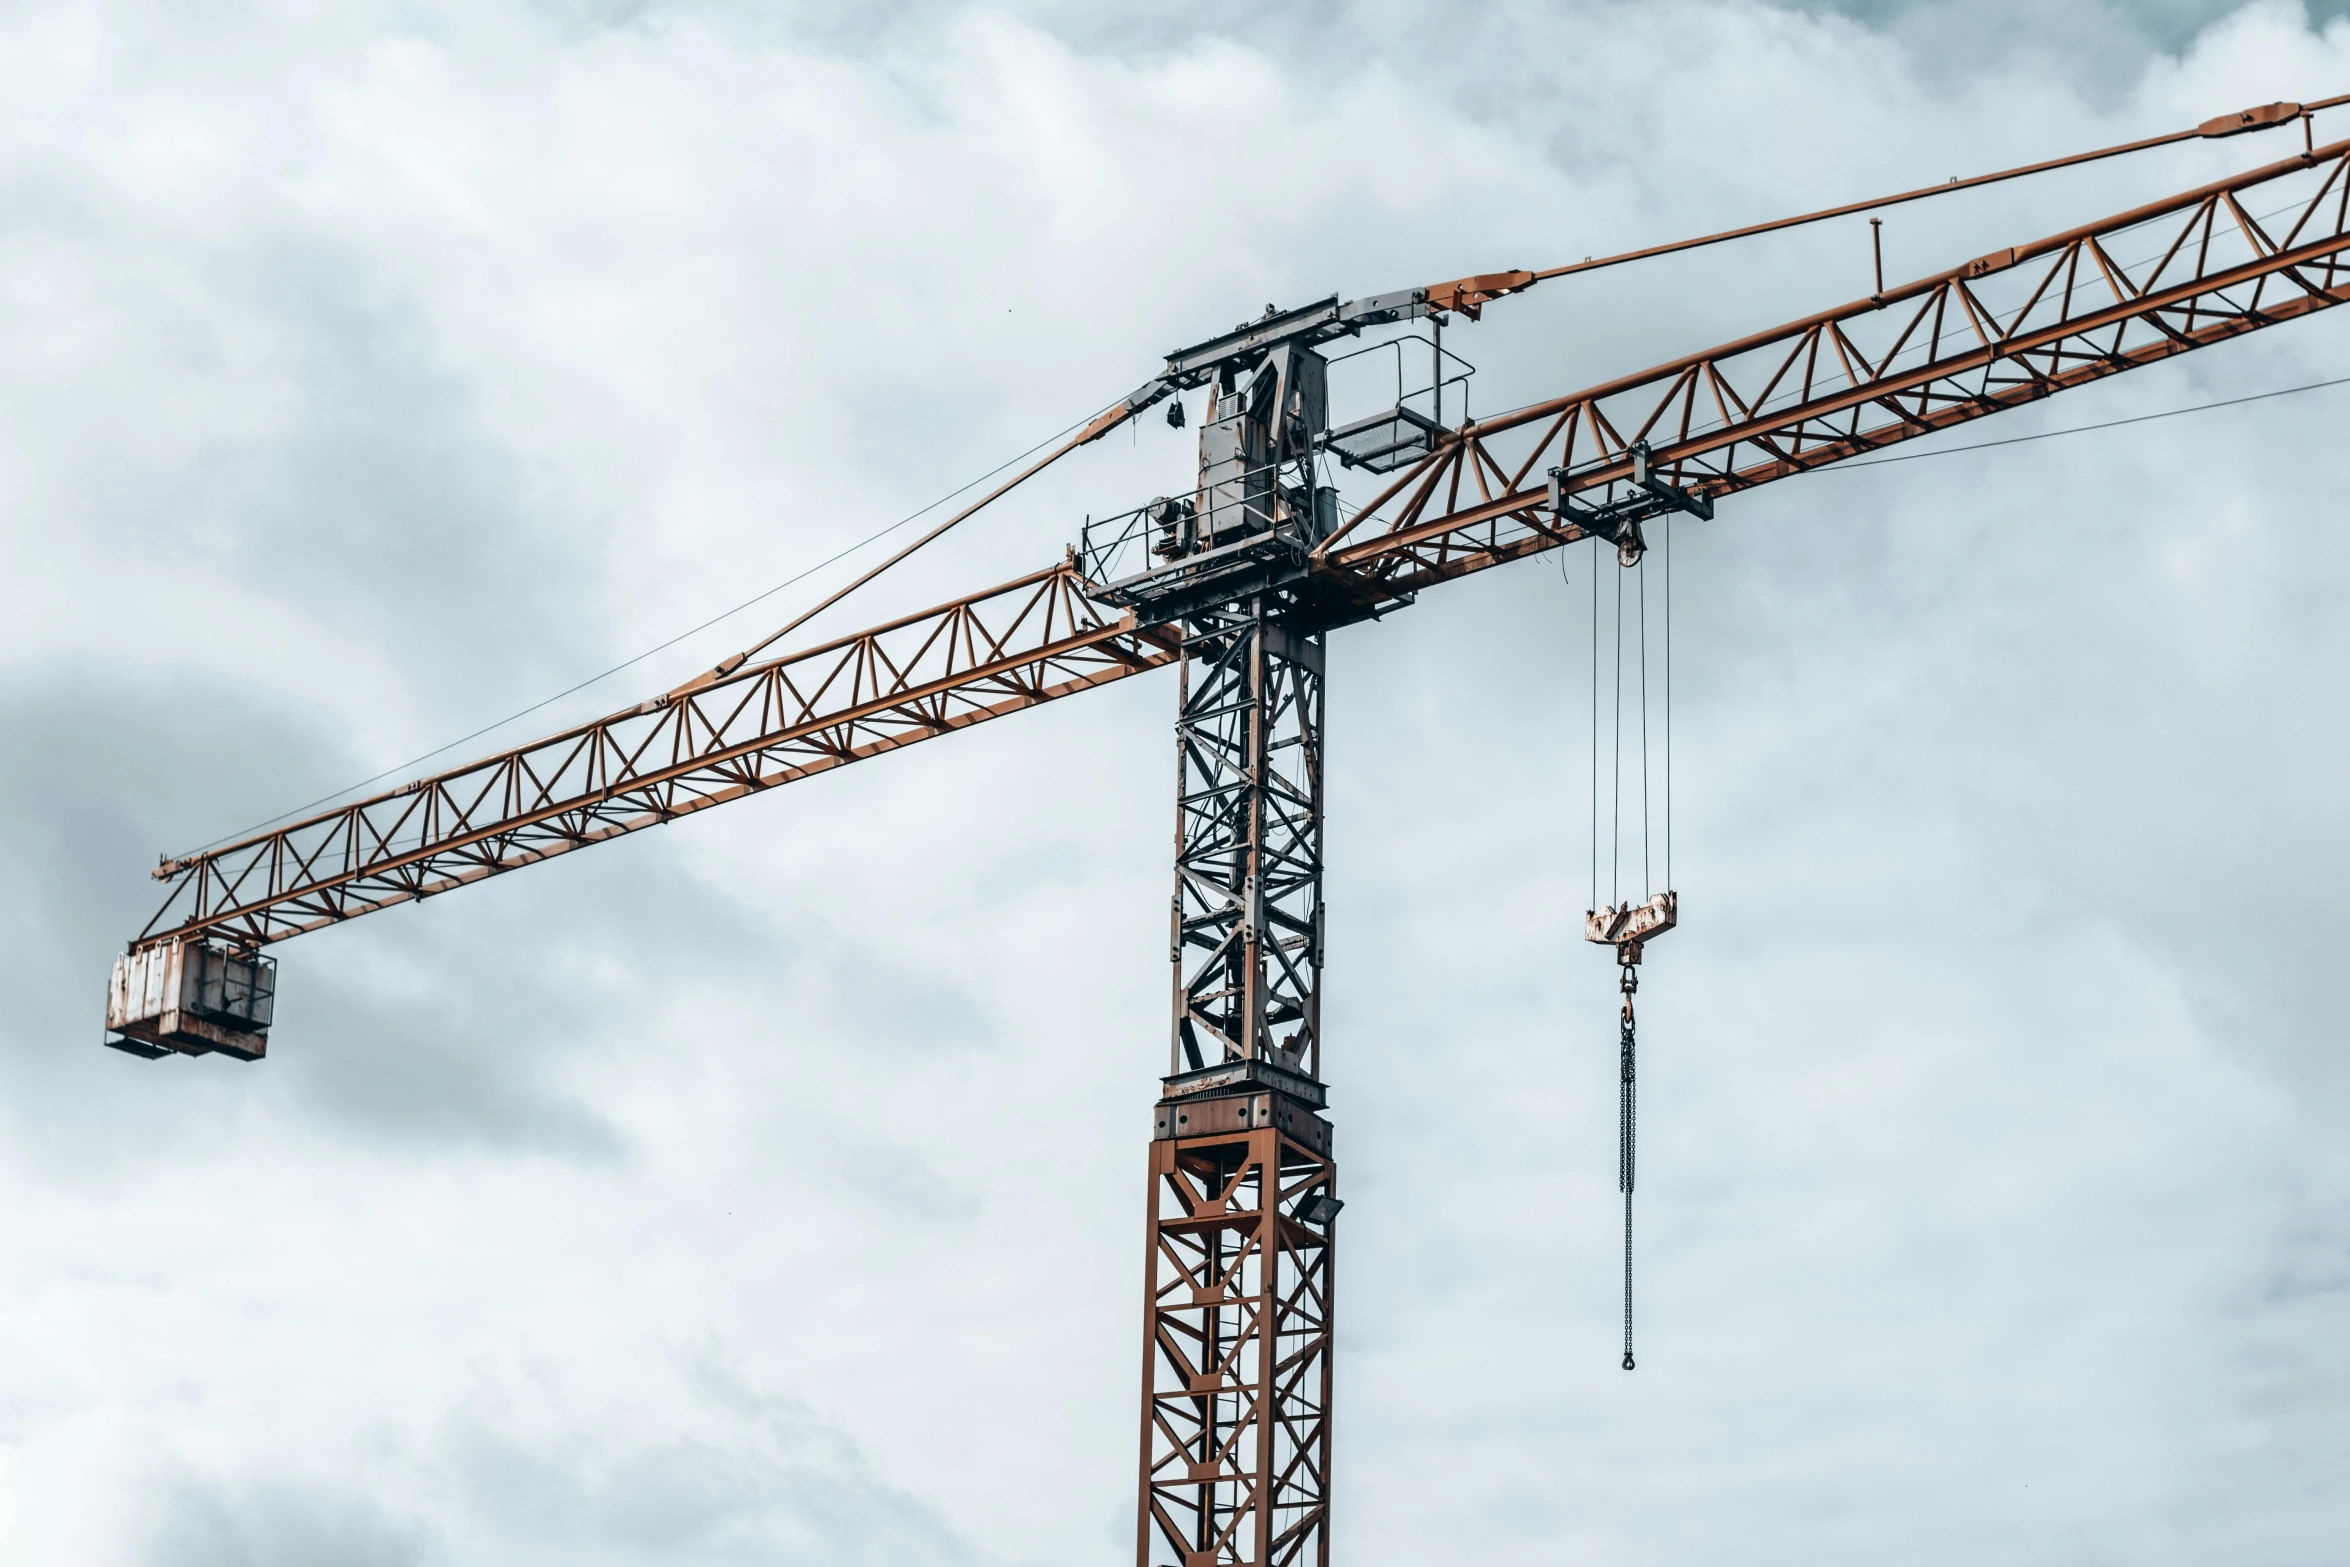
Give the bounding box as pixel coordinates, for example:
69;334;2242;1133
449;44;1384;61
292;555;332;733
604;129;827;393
134;566;1177;949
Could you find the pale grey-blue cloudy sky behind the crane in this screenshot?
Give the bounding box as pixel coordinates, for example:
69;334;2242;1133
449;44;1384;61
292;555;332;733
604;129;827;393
0;0;2350;1567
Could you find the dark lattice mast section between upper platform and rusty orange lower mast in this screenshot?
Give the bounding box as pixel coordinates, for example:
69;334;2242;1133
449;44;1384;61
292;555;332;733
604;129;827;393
1168;594;1323;1078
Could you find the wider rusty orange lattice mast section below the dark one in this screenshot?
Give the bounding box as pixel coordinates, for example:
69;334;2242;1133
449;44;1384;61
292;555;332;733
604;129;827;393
1135;1081;1340;1567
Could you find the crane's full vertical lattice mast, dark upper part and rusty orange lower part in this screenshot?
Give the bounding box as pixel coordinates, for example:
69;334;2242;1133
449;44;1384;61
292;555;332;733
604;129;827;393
1135;345;1340;1567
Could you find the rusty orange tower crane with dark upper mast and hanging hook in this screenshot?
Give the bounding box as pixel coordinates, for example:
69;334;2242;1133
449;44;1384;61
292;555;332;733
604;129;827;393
106;94;2350;1567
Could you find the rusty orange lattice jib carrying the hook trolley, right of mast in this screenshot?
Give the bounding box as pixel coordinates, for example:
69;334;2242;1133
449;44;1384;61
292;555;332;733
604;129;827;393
1316;130;2350;594
